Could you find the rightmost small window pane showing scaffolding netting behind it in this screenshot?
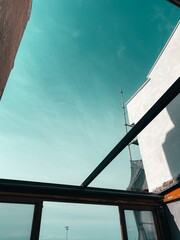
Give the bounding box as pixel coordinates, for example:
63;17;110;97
125;210;157;240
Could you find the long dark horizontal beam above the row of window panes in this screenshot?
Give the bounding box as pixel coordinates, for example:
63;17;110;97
0;179;162;206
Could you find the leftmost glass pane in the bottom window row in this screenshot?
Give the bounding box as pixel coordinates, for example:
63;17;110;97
0;203;34;240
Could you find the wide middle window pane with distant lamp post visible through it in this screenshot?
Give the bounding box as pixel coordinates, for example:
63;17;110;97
40;203;121;240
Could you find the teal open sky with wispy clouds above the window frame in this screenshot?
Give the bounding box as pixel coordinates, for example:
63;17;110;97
0;0;179;239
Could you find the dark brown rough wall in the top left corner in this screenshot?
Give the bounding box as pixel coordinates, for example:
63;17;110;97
0;0;32;98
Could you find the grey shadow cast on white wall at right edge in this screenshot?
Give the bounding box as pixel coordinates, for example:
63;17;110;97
162;95;180;177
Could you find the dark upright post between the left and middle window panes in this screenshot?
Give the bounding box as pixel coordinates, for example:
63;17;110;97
30;202;43;240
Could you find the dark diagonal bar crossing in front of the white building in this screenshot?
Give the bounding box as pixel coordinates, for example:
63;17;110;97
81;77;180;187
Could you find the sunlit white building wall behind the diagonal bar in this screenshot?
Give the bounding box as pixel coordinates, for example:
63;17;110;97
127;22;180;191
